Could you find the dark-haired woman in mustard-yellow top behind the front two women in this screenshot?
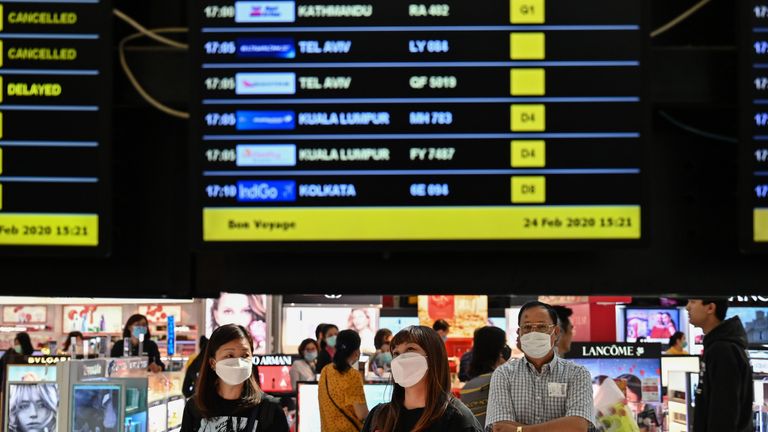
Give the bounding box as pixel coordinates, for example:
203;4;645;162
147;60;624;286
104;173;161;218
318;330;368;432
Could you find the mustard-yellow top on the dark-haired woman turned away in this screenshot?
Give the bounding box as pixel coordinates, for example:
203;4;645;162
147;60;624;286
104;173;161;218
317;364;365;432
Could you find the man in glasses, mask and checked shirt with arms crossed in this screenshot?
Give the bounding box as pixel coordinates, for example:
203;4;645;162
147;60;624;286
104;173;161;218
485;301;594;432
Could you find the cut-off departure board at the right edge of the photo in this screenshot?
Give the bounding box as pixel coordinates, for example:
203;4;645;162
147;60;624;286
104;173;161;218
740;0;768;251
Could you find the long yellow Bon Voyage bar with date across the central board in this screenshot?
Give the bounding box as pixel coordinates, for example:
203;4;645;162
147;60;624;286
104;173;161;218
203;205;640;242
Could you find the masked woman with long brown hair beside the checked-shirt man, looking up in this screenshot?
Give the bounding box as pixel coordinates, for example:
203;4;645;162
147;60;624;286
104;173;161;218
363;326;483;432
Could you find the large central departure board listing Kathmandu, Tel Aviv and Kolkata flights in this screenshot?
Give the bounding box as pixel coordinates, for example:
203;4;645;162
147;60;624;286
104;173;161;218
192;0;648;245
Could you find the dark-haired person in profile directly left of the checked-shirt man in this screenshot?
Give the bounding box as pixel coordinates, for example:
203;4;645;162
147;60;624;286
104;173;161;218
461;327;512;425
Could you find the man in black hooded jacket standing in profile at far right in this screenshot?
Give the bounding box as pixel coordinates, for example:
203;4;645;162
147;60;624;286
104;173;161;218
686;298;754;432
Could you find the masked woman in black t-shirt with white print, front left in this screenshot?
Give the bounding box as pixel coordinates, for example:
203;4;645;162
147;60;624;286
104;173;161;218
181;324;288;432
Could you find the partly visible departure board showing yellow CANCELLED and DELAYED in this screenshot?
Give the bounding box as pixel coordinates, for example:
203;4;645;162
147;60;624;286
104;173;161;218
0;0;112;254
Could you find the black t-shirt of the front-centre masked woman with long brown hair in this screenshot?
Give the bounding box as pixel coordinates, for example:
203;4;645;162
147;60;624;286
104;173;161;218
363;398;483;432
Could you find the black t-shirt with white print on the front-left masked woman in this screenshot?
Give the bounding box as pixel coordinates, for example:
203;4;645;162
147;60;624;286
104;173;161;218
181;395;288;432
